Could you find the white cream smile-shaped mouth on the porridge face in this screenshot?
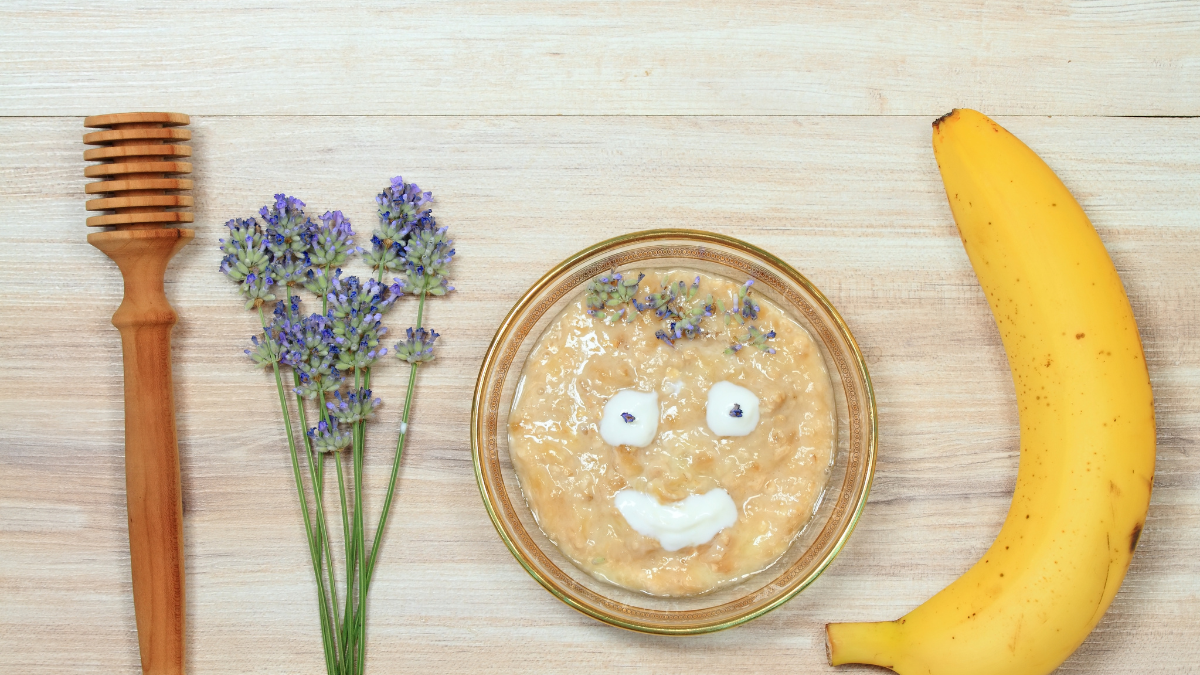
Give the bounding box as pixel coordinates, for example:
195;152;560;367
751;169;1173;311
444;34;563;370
613;488;738;551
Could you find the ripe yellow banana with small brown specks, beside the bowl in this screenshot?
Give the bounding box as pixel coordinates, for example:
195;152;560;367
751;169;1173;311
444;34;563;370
826;109;1154;675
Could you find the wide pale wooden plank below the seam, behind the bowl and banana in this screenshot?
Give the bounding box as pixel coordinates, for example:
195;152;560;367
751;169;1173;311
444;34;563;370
0;112;1200;675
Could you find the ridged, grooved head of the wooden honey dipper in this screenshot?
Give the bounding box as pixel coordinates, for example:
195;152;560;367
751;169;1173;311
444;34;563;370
83;113;193;229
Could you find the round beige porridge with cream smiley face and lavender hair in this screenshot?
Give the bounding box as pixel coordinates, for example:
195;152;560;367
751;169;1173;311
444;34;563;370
509;270;836;597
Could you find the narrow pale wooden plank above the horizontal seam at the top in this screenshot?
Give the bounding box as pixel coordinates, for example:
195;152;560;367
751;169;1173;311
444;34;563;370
0;0;1200;117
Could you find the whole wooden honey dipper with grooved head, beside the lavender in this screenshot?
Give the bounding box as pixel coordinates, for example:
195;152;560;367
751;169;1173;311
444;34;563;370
83;113;194;675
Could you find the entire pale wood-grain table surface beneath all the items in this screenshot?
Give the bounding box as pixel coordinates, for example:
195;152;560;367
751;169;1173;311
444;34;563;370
0;0;1200;675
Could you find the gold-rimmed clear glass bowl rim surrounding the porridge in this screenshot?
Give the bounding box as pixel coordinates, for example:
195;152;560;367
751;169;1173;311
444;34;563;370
470;229;877;635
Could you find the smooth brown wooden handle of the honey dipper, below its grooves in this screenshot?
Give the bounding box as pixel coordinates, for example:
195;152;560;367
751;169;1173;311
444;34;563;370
88;229;193;675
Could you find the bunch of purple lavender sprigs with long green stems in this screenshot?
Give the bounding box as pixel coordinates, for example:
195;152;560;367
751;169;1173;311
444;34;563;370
221;177;455;675
